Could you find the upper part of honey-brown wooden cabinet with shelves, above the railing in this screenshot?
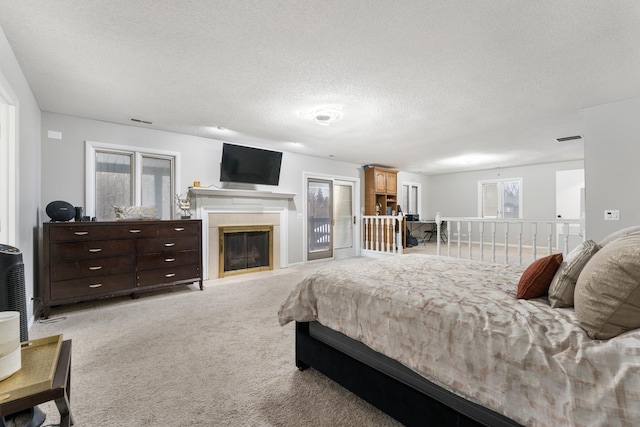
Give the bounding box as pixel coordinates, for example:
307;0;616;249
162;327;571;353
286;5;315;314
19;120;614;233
364;166;398;215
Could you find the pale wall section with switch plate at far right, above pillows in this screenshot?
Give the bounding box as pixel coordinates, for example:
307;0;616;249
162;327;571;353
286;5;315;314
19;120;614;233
583;98;640;242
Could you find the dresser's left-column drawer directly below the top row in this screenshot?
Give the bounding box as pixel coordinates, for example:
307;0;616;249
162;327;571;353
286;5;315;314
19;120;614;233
49;239;135;261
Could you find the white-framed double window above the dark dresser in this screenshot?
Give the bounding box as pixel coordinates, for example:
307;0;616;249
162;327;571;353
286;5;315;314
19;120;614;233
86;141;179;221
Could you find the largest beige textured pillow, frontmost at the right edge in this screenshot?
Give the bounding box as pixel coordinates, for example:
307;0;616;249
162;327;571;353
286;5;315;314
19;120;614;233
574;234;640;339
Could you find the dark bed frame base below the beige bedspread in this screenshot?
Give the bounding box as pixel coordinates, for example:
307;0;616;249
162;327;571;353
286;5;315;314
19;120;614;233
296;322;520;427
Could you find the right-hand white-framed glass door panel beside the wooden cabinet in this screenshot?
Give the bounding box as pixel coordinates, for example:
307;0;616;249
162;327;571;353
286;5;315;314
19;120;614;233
333;180;356;258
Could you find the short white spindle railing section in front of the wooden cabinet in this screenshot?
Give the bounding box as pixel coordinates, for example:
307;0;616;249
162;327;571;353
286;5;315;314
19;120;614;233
362;215;403;256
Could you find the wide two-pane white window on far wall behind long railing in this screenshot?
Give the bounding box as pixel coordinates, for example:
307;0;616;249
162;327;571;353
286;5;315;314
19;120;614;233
478;178;522;218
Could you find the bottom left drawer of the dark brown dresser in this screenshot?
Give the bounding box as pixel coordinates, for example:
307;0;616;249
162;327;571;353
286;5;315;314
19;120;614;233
51;273;135;300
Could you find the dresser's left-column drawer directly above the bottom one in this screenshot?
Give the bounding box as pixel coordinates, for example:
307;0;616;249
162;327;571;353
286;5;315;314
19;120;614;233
50;256;136;282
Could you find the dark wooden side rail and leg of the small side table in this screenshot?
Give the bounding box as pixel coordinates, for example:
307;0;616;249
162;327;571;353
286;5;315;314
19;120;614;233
0;340;73;427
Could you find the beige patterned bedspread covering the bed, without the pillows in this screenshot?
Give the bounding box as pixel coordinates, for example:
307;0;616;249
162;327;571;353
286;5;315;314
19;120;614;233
279;254;640;426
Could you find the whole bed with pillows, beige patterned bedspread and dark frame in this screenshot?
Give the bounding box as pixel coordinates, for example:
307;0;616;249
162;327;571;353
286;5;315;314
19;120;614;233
278;233;640;426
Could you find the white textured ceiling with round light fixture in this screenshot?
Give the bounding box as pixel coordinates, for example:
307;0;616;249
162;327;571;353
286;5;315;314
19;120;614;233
0;0;640;174
